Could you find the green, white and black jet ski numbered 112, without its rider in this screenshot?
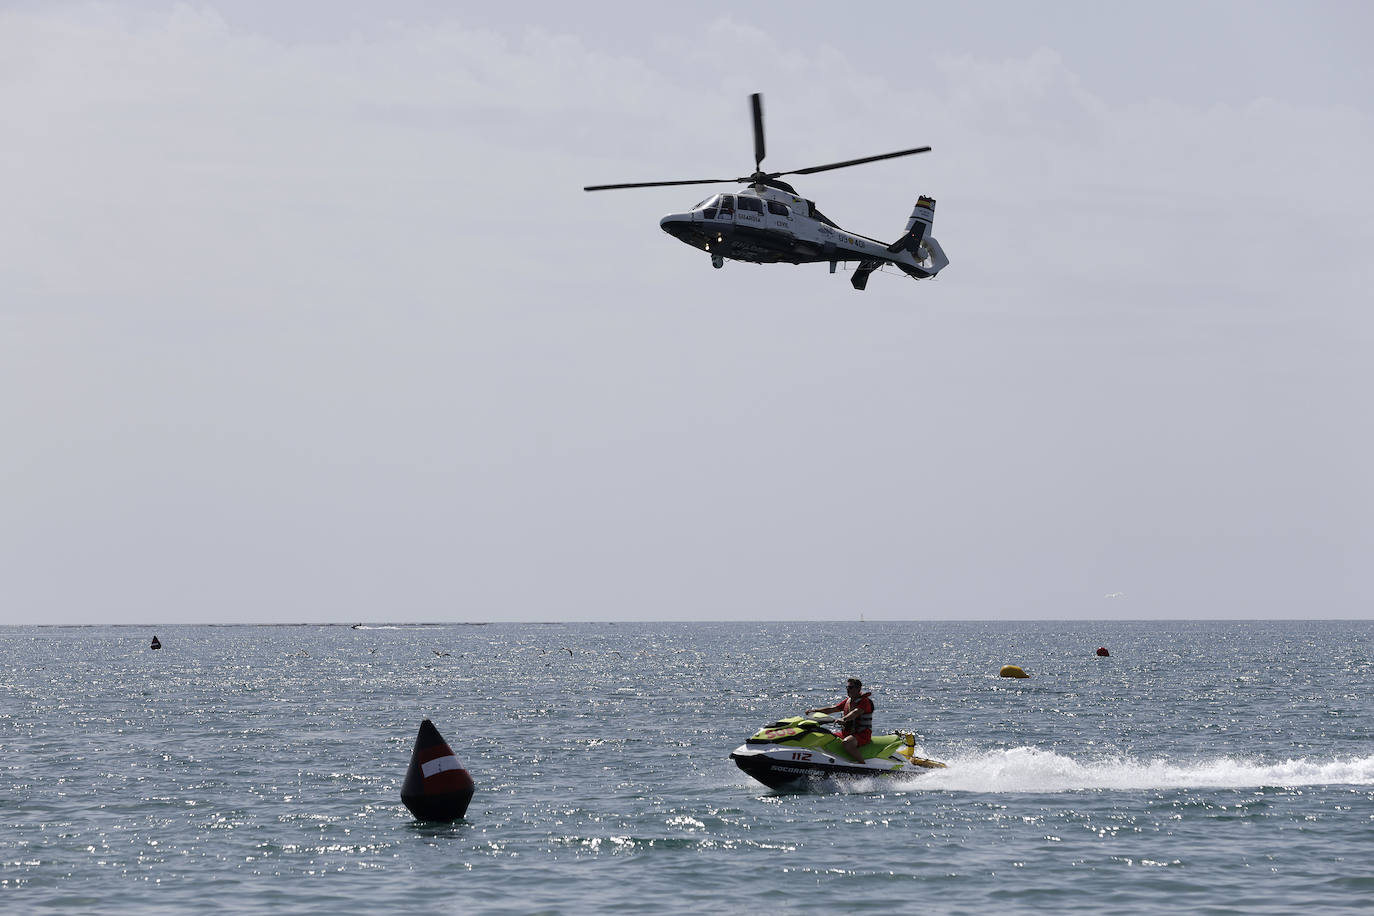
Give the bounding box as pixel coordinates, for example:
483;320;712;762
730;715;945;790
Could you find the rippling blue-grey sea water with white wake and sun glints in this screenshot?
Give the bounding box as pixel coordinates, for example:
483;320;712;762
0;622;1374;915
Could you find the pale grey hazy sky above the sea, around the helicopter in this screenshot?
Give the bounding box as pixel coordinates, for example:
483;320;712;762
0;0;1374;623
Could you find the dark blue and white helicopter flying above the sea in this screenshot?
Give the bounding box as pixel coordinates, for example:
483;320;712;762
583;92;949;290
